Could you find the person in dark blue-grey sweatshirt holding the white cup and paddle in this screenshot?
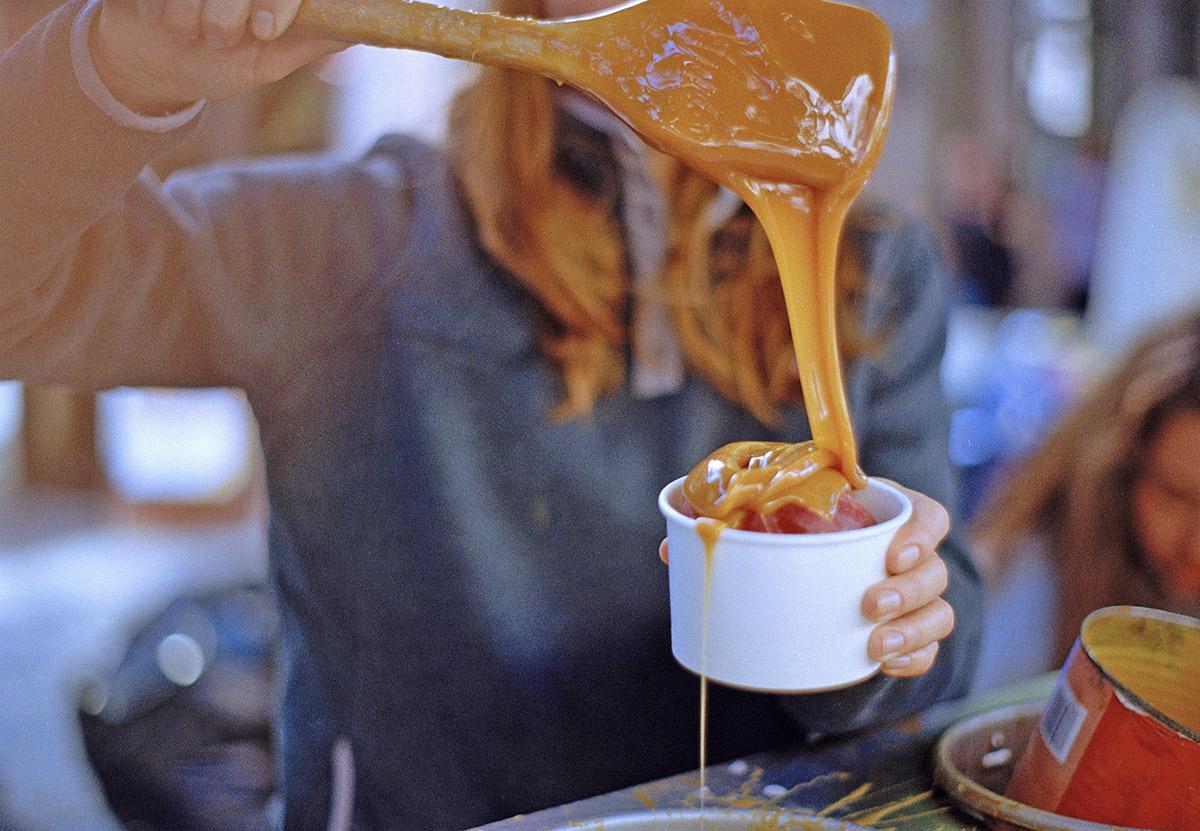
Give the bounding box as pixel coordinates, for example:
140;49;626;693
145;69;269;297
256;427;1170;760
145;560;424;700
0;0;979;829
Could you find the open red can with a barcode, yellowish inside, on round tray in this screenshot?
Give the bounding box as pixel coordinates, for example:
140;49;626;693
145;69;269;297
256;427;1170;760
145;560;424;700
1004;606;1200;831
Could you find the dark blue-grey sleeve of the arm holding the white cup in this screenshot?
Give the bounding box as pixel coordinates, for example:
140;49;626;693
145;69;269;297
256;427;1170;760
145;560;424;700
785;217;983;734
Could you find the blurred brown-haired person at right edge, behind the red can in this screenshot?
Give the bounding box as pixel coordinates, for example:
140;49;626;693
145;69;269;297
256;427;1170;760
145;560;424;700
972;312;1200;674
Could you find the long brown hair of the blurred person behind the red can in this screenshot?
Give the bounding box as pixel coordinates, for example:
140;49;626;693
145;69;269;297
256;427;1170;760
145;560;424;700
972;312;1200;660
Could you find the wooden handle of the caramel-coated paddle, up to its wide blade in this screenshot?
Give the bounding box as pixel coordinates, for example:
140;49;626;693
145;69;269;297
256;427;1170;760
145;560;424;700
295;0;576;80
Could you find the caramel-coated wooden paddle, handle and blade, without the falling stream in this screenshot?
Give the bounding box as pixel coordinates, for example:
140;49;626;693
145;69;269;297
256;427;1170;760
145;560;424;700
296;0;894;187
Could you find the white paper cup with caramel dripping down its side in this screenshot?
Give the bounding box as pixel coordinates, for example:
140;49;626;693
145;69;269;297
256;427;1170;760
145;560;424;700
659;478;912;693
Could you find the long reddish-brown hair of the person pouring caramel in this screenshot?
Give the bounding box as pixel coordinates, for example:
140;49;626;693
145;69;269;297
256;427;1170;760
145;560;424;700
448;0;863;425
